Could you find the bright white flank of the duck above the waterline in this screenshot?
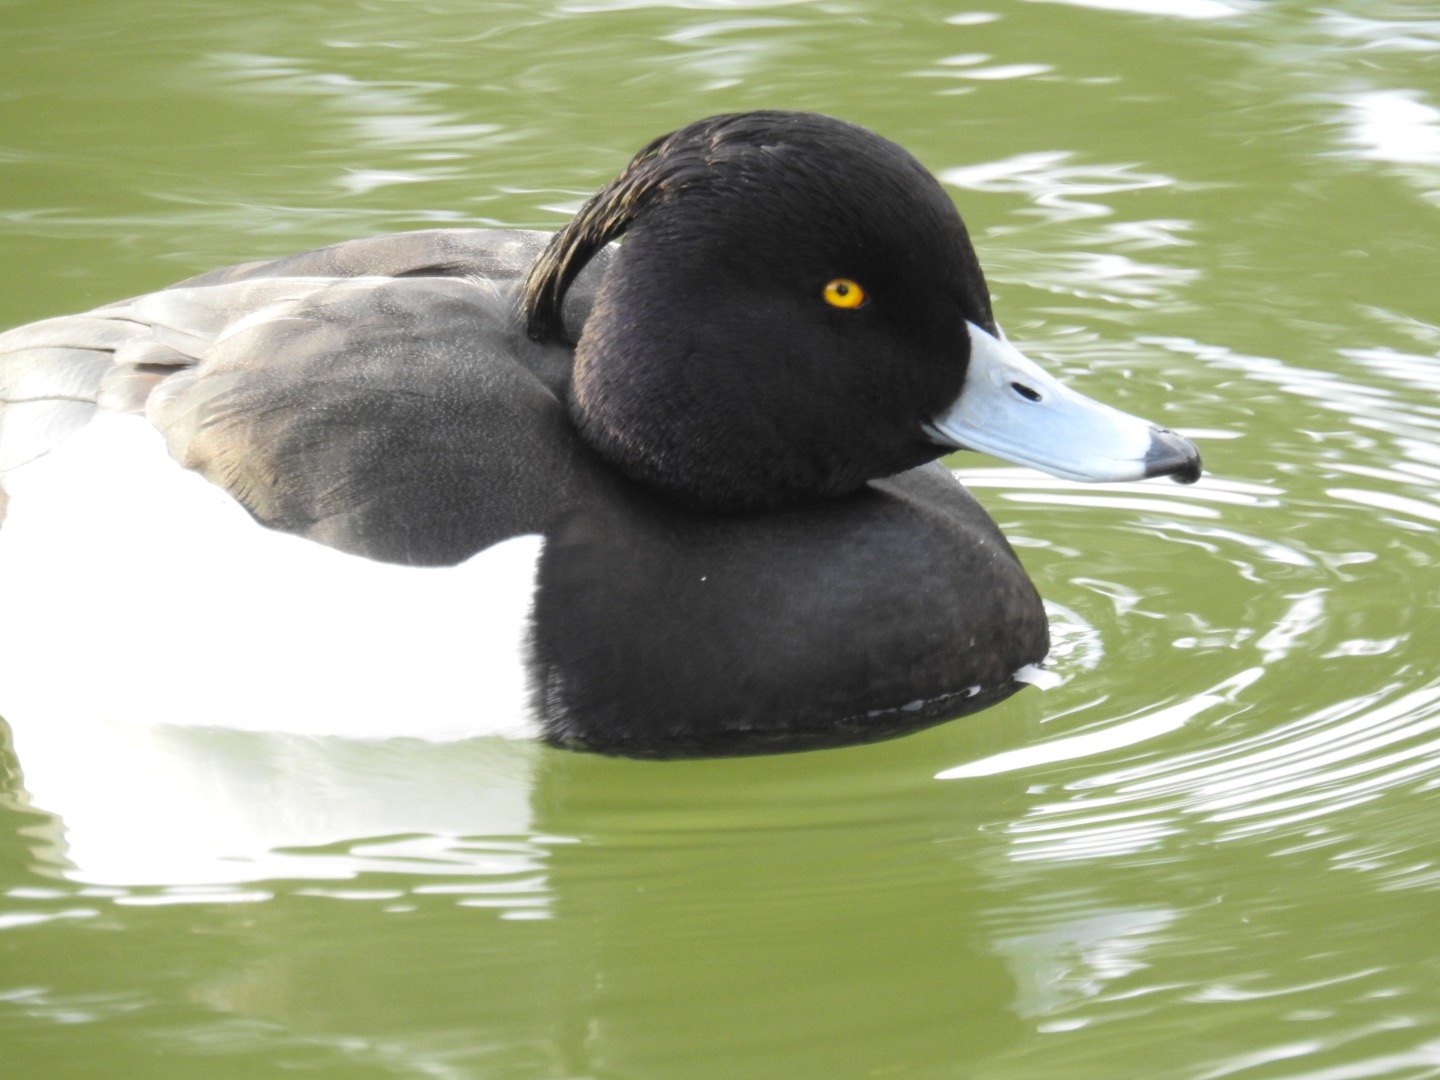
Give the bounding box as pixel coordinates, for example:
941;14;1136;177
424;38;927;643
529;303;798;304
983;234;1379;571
0;416;541;743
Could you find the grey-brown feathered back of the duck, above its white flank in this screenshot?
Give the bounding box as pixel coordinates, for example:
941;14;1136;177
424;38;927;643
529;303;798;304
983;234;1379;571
0;229;605;564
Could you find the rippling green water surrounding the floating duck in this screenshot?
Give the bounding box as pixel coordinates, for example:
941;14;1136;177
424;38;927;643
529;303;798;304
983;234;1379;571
0;0;1440;1080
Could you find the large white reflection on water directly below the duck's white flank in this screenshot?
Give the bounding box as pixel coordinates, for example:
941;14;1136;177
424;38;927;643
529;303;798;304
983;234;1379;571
7;724;550;917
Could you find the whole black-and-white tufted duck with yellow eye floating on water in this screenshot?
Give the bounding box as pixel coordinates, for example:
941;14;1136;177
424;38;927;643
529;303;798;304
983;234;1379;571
0;111;1201;763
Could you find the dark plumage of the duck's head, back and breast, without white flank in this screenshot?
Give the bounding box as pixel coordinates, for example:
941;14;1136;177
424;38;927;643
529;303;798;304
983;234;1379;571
0;112;1198;756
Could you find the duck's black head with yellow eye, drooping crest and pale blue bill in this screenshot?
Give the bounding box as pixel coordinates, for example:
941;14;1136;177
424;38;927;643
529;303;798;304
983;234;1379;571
526;112;1200;510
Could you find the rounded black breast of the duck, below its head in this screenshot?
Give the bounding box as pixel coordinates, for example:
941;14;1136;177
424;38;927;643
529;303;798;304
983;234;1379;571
534;465;1048;756
